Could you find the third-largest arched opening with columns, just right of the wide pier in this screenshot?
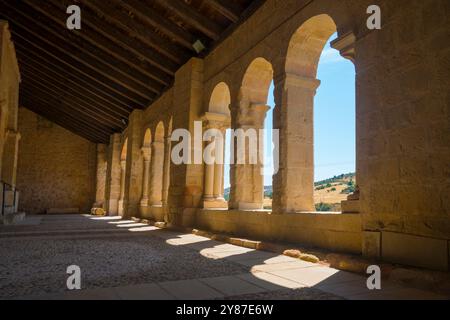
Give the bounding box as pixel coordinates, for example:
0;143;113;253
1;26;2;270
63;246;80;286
203;82;231;209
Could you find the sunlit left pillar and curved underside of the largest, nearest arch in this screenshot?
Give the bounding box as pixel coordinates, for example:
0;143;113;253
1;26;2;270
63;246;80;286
273;14;352;212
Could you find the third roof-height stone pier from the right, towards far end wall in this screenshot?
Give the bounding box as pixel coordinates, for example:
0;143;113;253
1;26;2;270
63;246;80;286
105;133;121;216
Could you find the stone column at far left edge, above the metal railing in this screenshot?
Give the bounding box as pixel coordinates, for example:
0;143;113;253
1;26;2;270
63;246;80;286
2;130;20;187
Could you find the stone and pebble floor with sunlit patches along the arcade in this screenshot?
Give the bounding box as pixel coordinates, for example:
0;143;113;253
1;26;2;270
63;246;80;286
0;215;448;300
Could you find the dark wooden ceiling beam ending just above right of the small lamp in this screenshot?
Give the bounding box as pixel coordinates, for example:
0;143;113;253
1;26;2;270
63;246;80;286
156;0;223;40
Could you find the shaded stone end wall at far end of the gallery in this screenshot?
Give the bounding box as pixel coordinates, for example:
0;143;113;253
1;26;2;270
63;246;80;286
17;108;96;214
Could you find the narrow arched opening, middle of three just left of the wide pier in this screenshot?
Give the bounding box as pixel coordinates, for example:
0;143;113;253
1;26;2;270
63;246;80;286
149;121;165;221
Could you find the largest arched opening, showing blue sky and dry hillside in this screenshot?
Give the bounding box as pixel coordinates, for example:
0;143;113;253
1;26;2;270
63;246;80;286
314;33;356;212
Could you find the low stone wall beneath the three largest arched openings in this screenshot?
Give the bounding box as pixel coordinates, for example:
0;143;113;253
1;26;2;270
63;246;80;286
194;210;362;254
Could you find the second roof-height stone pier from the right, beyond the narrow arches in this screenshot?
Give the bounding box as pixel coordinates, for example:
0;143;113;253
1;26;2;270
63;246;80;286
124;110;144;218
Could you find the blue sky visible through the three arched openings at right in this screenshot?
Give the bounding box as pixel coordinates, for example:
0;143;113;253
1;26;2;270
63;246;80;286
224;35;356;188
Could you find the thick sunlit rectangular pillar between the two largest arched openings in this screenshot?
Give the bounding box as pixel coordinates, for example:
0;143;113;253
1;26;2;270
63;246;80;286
273;74;320;213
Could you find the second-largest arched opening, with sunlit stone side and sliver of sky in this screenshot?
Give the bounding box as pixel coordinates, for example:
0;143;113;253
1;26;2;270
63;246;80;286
230;58;273;210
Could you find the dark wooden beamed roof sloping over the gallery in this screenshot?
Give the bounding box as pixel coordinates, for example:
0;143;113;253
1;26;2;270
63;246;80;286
0;0;264;143
